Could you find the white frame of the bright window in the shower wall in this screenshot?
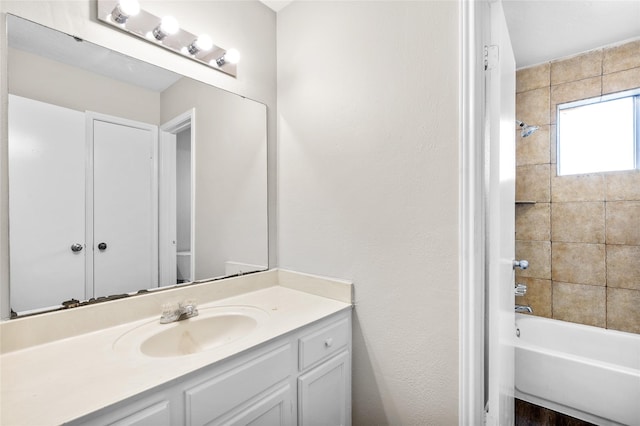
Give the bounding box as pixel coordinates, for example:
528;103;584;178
556;87;640;177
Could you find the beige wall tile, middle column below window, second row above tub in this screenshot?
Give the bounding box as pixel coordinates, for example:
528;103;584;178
551;242;606;286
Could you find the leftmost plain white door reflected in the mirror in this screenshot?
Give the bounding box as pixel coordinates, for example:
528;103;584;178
9;95;87;312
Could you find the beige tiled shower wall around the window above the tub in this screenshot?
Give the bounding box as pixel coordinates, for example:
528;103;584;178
516;40;640;333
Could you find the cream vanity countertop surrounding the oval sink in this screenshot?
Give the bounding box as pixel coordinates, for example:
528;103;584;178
0;271;352;426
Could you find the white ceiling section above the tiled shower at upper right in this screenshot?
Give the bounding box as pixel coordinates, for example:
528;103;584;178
502;0;640;68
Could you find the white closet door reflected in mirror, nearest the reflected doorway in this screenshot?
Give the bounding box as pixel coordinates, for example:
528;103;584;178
90;115;158;297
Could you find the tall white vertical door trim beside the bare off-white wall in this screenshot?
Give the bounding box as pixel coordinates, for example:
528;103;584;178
458;0;485;425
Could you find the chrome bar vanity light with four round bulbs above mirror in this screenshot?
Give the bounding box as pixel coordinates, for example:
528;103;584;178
97;0;240;77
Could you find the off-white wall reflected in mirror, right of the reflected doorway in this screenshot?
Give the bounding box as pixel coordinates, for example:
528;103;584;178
160;78;267;280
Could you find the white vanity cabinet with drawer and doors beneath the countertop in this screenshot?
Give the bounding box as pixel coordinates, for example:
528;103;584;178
71;310;351;426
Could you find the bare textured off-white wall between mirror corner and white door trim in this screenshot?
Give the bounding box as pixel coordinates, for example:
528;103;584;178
278;1;459;425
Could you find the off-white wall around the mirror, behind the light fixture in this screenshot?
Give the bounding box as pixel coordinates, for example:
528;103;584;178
0;0;276;312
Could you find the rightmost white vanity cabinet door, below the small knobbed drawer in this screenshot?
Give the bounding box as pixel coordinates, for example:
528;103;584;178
298;351;351;426
